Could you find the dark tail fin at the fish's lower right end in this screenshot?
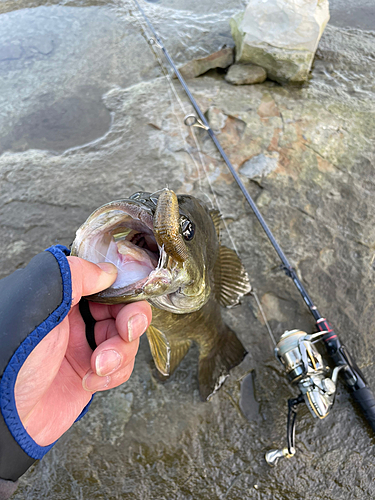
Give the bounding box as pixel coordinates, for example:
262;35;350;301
199;325;247;401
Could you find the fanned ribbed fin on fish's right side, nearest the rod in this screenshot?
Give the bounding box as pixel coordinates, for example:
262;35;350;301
215;245;251;307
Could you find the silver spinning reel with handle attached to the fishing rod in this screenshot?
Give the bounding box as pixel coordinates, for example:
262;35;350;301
265;330;344;467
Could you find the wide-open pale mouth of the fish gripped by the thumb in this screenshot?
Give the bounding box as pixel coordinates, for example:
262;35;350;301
71;193;181;302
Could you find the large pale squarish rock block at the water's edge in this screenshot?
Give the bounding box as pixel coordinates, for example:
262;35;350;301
230;0;329;83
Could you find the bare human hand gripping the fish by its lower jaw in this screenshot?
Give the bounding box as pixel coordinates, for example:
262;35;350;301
15;257;151;446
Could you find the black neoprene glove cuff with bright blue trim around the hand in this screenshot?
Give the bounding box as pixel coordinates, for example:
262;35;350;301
0;245;93;486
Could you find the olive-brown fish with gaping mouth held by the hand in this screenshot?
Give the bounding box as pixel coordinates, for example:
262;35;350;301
71;189;251;400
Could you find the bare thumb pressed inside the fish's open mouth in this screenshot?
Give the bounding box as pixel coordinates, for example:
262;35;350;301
68;257;117;306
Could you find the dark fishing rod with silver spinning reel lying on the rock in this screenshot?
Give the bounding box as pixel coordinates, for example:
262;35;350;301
133;0;375;466
